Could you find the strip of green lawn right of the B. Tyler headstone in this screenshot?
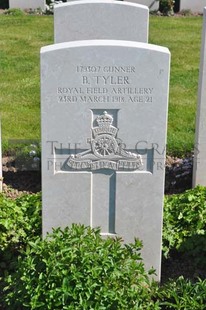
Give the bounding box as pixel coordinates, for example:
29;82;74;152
150;17;202;154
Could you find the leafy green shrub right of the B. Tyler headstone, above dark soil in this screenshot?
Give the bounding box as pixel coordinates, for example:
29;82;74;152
163;186;206;264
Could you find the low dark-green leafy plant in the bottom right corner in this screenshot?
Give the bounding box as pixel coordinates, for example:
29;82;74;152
158;277;206;310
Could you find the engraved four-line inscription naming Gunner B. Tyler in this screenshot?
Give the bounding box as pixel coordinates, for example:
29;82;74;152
57;65;155;104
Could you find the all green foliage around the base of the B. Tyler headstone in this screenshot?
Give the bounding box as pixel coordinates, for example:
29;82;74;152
0;186;206;310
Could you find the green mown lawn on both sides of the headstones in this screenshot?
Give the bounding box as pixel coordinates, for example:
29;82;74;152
0;15;202;154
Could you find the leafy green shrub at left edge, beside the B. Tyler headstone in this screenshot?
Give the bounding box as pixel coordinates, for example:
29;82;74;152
0;194;41;277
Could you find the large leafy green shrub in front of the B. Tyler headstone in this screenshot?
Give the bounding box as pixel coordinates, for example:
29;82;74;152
2;225;159;310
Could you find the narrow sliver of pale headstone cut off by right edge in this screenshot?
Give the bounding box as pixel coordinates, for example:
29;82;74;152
193;8;206;187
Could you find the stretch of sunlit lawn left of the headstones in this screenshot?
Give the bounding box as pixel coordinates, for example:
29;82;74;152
0;15;53;149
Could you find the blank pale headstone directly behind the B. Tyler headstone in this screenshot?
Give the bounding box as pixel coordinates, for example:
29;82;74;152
54;0;149;43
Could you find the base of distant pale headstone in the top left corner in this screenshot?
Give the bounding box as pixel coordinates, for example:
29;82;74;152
9;0;46;10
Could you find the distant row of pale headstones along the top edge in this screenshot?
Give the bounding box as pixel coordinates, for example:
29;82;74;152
6;0;206;12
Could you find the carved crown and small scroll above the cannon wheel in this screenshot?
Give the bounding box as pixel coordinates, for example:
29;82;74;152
92;111;118;137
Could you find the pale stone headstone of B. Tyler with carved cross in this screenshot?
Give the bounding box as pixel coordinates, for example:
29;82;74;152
41;40;170;280
